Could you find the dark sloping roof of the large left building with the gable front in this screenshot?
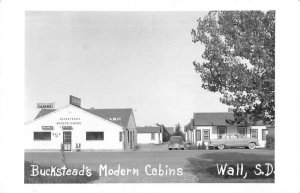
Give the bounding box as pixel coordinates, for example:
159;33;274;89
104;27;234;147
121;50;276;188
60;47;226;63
35;107;132;127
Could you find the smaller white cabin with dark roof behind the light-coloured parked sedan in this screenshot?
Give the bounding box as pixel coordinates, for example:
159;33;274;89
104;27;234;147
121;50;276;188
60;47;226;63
184;109;268;148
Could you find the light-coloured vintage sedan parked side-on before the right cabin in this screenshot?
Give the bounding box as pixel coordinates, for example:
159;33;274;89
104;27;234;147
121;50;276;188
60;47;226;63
208;133;259;149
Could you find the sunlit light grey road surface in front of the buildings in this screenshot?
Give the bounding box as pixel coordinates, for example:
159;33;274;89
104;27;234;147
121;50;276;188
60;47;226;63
25;149;274;183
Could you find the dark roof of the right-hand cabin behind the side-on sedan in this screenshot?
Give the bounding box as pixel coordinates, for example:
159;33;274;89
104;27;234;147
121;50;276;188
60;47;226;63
194;112;264;126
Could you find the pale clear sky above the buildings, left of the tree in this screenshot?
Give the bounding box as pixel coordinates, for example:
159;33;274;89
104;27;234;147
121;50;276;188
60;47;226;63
25;12;228;126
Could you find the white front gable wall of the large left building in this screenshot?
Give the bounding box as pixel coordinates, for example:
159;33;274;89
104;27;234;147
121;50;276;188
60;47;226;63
25;105;123;150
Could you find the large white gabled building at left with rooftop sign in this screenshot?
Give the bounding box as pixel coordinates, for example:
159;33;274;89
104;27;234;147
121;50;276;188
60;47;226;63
25;96;137;151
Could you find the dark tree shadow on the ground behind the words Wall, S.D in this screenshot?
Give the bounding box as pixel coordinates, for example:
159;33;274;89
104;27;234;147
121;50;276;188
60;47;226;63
186;152;275;183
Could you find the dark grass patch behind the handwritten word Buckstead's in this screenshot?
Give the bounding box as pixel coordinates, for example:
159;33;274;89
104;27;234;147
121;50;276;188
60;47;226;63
24;161;99;184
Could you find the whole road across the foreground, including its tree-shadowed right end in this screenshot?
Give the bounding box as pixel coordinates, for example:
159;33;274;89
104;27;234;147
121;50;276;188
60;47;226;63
25;149;275;183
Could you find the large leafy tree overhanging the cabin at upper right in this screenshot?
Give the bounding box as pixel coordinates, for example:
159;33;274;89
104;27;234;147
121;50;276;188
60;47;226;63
192;11;275;124
